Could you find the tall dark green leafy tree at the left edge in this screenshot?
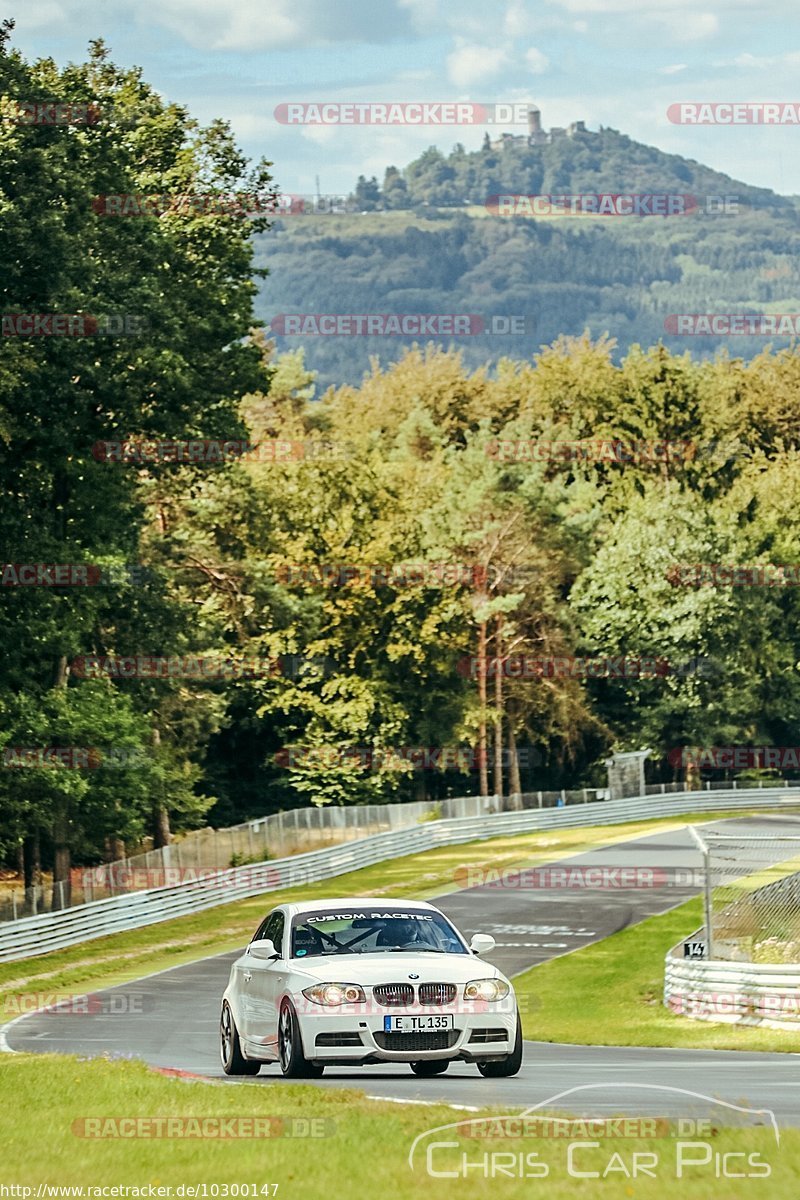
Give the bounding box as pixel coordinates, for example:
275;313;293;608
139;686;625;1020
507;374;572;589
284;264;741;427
0;31;270;883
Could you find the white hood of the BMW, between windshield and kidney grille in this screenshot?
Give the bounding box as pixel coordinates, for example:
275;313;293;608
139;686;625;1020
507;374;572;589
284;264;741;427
291;952;505;988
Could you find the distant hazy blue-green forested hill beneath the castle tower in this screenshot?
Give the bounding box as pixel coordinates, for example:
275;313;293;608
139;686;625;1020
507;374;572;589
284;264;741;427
257;130;800;385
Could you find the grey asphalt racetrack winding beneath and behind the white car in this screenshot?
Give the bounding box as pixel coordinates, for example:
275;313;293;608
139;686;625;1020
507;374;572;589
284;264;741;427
6;815;800;1126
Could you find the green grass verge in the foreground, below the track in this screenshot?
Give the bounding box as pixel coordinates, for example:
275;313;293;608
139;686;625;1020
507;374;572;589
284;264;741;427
0;1055;800;1200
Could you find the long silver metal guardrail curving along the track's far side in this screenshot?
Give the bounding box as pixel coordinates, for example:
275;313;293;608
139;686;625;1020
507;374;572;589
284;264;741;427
0;787;800;961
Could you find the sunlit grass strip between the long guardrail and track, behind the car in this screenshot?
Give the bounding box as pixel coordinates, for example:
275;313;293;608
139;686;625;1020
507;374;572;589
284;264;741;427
0;812;762;1025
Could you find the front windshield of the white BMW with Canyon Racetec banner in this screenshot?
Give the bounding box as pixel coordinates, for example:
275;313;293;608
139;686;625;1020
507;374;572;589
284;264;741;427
291;908;469;959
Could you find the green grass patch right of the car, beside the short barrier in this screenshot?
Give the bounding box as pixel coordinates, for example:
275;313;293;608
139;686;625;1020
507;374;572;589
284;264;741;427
513;898;800;1052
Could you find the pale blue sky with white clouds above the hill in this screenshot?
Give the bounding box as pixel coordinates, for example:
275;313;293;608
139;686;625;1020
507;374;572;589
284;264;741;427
4;0;800;194
